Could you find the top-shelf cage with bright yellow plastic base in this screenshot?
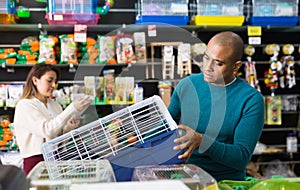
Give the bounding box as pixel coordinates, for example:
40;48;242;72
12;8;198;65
191;0;245;26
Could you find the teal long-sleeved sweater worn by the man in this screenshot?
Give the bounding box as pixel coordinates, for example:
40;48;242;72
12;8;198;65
168;73;264;181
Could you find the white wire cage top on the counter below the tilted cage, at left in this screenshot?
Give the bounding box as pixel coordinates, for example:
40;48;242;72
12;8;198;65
27;159;116;189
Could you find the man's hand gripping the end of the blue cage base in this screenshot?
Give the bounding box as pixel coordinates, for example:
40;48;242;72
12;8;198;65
173;125;202;160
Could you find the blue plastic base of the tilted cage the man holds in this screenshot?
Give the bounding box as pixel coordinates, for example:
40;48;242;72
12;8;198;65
108;130;184;181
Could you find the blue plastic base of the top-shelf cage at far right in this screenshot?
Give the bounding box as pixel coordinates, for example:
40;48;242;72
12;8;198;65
249;16;298;26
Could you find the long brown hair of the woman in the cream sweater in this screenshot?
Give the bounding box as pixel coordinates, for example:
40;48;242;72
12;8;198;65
22;64;60;99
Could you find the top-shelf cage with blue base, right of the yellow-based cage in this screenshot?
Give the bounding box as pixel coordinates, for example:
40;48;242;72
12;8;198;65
250;0;299;26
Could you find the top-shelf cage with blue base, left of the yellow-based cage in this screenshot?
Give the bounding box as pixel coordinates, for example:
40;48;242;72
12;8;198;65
136;0;189;25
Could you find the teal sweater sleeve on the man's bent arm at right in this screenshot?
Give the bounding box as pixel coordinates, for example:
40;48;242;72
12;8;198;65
199;94;264;170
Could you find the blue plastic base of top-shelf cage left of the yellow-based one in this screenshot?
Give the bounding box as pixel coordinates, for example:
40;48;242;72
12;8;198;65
135;15;189;25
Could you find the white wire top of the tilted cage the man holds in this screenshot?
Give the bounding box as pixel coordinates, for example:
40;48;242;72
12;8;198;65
42;96;177;180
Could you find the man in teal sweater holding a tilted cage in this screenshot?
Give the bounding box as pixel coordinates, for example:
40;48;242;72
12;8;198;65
168;31;264;181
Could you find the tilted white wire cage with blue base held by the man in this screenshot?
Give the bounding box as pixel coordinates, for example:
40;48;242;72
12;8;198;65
42;96;184;181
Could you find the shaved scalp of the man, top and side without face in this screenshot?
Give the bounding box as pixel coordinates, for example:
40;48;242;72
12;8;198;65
209;31;244;61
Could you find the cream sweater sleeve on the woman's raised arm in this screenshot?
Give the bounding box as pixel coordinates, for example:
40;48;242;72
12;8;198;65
14;100;76;139
